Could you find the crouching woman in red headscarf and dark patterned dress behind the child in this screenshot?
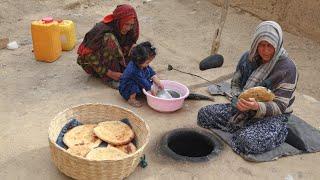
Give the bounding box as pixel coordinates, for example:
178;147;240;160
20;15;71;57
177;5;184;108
77;4;139;89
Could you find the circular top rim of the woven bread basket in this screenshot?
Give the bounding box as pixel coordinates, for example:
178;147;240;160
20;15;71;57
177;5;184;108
48;103;150;162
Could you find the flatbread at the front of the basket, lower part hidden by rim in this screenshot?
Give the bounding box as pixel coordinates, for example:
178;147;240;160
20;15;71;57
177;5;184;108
86;145;127;160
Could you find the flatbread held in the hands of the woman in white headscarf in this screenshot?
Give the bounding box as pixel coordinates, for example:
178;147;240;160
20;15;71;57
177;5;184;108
238;86;275;102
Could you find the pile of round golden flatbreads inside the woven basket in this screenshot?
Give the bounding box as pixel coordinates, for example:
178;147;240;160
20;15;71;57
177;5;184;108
63;121;137;160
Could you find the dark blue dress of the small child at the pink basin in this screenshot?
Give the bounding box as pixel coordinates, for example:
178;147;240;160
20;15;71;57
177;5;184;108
119;61;156;100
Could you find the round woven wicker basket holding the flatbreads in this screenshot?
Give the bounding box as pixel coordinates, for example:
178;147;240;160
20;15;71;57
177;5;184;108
49;104;150;179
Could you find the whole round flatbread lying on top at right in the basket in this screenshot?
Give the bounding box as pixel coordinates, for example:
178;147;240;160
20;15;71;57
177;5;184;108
93;121;134;146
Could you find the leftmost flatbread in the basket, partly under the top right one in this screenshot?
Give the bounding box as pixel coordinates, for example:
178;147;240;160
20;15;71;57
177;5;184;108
63;124;102;148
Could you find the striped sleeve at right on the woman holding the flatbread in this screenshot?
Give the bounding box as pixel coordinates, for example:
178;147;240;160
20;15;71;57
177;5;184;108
255;60;298;118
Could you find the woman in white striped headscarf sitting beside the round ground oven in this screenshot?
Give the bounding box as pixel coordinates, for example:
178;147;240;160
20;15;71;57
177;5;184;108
198;21;298;154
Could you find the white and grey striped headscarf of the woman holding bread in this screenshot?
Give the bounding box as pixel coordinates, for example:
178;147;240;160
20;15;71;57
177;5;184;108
244;21;287;90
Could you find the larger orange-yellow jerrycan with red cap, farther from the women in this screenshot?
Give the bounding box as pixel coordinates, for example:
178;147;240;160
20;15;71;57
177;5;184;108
31;18;62;62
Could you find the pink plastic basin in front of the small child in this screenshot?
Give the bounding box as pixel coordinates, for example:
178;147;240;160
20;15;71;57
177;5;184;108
143;80;189;112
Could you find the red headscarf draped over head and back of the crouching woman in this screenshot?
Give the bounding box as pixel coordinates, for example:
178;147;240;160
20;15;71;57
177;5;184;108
78;4;139;55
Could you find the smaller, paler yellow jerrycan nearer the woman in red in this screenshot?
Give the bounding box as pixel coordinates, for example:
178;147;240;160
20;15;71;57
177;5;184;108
58;20;76;51
